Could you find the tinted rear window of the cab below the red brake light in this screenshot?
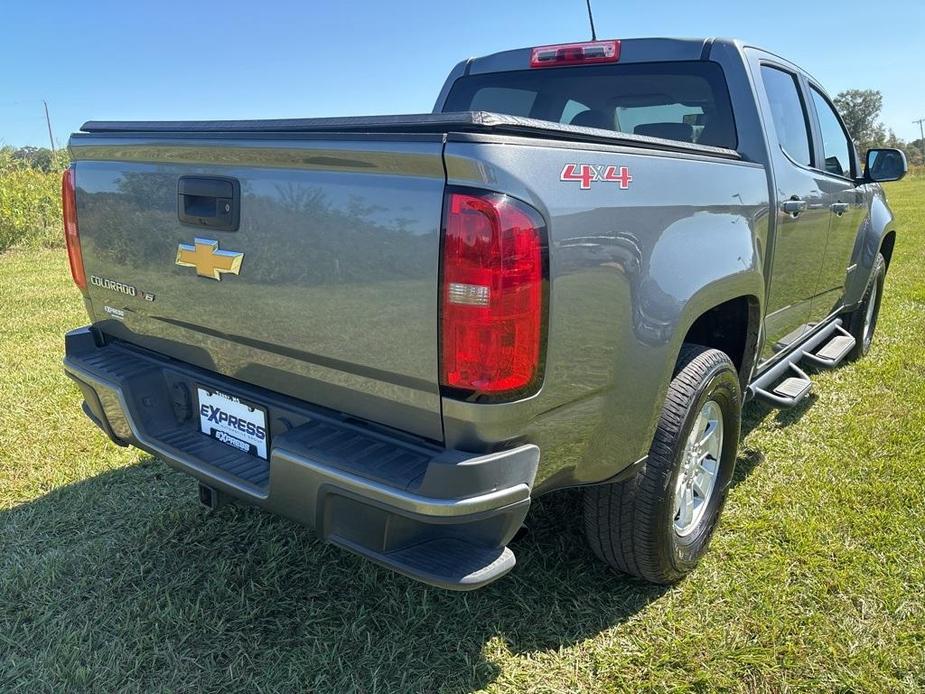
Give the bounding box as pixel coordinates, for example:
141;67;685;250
443;61;737;149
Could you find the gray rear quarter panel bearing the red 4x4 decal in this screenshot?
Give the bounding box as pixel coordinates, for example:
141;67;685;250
443;136;768;491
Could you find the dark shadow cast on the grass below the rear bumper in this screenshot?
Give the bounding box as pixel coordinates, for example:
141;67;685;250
0;458;665;692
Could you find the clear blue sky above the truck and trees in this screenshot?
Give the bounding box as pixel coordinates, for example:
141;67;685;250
0;0;925;145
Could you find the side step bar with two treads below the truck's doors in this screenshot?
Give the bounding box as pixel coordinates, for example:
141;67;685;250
747;318;855;407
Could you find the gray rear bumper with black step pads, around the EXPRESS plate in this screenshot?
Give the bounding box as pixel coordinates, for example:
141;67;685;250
64;328;539;590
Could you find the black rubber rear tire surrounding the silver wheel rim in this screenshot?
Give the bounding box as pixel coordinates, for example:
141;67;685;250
584;344;742;584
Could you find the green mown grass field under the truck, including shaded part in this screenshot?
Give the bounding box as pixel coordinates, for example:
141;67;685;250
0;178;925;692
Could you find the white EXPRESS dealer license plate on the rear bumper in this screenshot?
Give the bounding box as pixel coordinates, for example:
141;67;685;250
196;386;269;460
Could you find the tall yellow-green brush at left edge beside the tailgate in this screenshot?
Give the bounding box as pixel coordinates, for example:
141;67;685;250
0;166;64;252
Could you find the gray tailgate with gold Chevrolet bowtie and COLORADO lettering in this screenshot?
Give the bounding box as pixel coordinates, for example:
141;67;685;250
71;133;445;440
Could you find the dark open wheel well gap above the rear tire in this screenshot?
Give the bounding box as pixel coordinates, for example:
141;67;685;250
684;296;759;379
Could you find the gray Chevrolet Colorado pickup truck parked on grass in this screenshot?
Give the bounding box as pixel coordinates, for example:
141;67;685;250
62;39;906;590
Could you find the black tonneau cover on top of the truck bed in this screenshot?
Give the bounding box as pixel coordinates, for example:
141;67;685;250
80;111;739;159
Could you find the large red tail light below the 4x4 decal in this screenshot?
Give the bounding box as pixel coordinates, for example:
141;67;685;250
440;191;546;396
